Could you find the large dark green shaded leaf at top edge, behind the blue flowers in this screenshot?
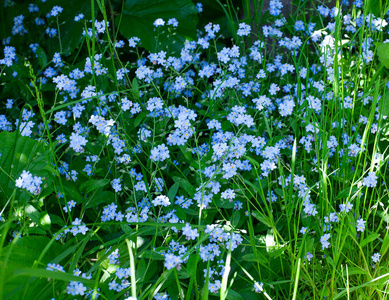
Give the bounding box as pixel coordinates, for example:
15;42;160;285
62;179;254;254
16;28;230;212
115;0;198;53
